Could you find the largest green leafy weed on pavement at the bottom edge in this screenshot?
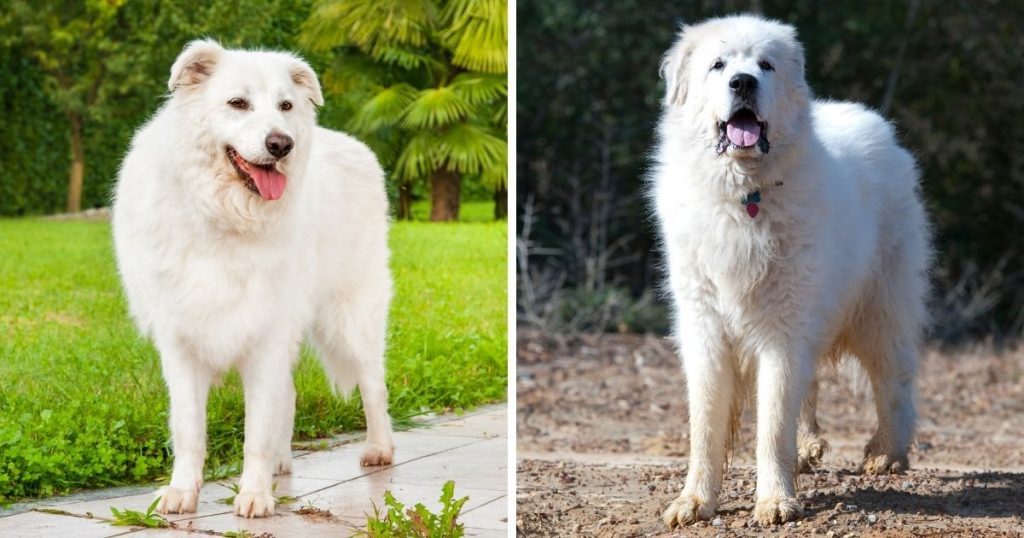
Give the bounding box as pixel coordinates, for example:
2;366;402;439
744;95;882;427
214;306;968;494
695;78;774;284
356;481;469;538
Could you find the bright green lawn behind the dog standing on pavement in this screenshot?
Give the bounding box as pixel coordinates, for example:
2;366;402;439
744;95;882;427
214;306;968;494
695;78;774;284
0;219;507;502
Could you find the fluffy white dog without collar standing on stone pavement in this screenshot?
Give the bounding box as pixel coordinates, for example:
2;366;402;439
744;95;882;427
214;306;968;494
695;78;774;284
113;40;393;518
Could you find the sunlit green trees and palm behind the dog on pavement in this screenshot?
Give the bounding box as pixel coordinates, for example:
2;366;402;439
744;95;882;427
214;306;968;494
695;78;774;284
0;0;508;220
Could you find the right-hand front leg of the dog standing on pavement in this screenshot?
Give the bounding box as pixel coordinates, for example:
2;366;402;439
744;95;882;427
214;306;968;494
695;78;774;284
234;345;297;518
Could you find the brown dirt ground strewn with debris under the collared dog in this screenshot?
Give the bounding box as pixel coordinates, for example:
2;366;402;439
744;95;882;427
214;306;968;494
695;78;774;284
516;329;1024;538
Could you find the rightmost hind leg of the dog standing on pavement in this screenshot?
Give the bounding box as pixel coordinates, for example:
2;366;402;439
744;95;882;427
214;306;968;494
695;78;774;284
313;280;394;465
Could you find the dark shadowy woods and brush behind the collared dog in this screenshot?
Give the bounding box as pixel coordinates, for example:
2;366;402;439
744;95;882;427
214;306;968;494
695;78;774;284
516;0;1024;342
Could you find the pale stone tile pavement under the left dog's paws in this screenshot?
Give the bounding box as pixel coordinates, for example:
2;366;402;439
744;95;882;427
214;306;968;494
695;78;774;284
0;404;509;538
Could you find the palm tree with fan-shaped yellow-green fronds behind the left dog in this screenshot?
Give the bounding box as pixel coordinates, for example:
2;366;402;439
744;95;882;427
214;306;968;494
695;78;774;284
300;0;508;220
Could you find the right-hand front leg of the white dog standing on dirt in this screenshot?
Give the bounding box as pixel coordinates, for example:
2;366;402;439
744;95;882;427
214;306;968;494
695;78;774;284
754;344;814;527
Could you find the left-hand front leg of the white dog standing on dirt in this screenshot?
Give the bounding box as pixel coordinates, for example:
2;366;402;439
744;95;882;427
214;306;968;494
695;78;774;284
663;311;736;527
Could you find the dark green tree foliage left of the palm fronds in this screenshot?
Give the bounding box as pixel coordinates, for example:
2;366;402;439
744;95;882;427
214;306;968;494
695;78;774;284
0;0;311;215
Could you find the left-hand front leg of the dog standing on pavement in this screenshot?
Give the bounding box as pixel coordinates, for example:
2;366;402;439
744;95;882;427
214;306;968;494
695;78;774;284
157;345;213;513
